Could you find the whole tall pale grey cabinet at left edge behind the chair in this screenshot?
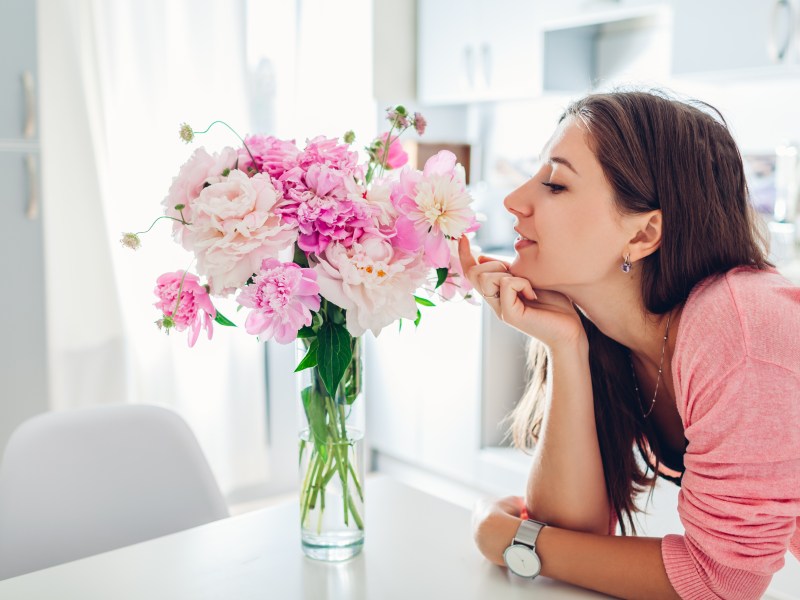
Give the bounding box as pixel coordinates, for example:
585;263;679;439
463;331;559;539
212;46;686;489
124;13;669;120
0;0;48;454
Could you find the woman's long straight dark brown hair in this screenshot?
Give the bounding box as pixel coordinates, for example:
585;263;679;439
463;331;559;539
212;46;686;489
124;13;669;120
510;91;772;535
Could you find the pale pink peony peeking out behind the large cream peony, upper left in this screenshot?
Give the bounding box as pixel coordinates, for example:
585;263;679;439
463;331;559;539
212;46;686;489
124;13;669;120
161;148;236;241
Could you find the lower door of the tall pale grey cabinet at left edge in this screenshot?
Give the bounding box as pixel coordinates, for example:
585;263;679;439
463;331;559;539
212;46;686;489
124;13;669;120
0;152;48;452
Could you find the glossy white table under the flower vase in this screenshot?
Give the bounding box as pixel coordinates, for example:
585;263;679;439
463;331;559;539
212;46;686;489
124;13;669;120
0;476;606;600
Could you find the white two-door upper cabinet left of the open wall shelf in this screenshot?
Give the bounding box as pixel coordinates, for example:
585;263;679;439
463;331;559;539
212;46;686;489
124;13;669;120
417;0;541;105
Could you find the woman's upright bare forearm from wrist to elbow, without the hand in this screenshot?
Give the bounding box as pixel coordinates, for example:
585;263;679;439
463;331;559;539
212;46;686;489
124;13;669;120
526;343;611;534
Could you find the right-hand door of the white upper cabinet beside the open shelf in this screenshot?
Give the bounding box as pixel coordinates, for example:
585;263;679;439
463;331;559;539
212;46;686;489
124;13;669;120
476;0;541;100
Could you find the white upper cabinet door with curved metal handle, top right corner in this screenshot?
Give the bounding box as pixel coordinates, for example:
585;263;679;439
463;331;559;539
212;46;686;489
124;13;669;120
672;0;800;75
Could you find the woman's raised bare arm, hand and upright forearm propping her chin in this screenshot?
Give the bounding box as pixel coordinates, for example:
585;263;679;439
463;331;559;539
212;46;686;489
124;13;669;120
459;237;610;534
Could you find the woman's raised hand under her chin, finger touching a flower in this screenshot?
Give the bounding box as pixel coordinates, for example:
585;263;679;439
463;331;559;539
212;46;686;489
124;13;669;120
458;236;586;348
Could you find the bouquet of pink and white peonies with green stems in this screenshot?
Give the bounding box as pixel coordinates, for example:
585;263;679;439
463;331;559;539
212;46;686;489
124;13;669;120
122;106;477;560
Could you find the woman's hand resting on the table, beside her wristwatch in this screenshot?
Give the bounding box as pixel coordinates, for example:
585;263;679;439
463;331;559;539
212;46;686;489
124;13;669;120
472;496;527;566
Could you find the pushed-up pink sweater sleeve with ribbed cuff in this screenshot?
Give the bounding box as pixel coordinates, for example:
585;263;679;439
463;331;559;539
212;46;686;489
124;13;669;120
661;355;800;600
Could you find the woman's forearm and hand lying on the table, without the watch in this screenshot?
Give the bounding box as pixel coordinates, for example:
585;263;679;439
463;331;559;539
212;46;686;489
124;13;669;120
475;498;680;600
